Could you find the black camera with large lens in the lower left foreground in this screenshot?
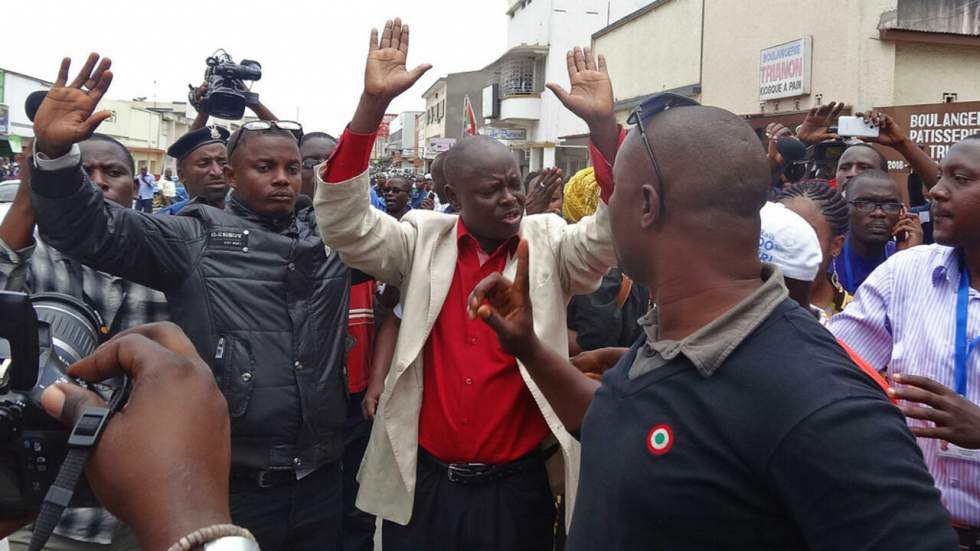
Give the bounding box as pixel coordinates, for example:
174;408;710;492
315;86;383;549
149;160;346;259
0;291;117;518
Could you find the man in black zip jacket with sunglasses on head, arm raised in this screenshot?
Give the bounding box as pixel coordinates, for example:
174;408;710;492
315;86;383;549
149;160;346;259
32;54;360;550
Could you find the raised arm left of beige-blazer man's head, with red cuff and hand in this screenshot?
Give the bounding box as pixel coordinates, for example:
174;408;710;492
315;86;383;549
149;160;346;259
314;19;431;286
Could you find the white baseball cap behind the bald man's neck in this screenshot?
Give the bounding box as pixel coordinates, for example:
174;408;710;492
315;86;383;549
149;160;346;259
759;202;823;281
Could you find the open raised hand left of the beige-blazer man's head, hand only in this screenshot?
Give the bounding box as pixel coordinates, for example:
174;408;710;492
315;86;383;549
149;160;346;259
364;17;432;101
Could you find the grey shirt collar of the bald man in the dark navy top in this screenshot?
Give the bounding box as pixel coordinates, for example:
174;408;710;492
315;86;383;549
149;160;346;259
629;263;789;379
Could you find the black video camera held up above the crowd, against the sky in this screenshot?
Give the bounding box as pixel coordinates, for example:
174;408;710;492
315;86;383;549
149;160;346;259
188;50;262;120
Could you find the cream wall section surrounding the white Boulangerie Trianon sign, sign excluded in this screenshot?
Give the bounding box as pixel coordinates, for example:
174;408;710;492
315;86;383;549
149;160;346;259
702;0;897;113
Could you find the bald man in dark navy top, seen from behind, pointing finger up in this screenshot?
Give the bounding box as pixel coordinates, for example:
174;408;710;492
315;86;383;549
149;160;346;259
470;72;956;551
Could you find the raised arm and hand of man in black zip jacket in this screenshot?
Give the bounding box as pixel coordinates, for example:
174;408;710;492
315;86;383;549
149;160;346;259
31;54;204;290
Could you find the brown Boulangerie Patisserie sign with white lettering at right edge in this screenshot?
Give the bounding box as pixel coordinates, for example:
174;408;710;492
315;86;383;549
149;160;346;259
876;101;980;172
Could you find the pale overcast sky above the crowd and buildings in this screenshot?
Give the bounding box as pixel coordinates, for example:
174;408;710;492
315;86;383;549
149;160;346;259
7;0;507;133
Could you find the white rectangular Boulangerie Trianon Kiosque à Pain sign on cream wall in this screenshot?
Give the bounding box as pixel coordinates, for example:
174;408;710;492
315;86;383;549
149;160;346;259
759;36;811;101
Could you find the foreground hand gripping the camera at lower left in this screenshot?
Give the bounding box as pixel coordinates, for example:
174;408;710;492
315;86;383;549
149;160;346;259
41;323;231;550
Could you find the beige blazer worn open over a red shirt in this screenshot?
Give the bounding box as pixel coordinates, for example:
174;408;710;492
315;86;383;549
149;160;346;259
314;167;616;524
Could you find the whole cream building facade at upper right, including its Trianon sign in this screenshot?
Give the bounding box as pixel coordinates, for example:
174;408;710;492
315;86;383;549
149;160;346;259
592;0;980;126
